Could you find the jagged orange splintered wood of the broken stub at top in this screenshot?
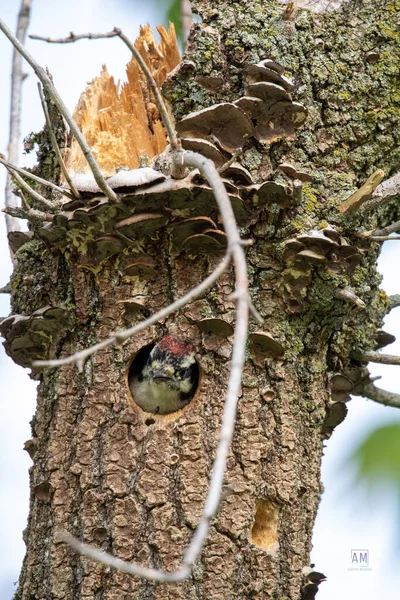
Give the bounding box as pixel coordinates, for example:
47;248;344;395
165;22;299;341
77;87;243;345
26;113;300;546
65;24;180;176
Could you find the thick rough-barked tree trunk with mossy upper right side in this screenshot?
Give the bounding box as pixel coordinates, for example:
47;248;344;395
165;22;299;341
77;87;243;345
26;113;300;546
1;0;400;600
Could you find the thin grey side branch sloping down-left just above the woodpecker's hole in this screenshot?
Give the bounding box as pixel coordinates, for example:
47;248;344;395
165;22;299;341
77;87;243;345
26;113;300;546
32;252;231;367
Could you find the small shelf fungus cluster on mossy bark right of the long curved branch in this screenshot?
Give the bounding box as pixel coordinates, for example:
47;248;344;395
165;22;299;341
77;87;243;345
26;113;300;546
283;226;361;313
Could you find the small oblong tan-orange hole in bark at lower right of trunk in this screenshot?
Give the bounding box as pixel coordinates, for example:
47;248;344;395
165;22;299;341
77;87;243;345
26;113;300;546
250;499;279;554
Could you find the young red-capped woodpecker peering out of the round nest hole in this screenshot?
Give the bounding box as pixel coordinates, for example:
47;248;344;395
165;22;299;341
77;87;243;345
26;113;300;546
129;335;199;415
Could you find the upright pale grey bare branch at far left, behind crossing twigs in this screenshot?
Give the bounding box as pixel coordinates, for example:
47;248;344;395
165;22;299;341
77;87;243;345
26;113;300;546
5;0;31;246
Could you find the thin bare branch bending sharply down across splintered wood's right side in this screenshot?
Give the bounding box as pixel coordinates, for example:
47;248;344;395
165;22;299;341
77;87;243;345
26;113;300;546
30;27;182;156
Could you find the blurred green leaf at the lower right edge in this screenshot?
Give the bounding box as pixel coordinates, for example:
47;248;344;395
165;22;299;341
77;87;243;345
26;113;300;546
351;423;400;490
